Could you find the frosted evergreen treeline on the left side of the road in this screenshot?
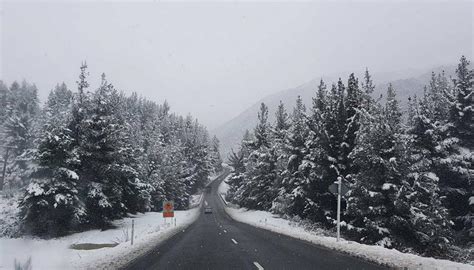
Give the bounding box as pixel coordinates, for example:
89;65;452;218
0;64;222;235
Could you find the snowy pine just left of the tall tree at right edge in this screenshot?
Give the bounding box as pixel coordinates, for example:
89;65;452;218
397;80;453;255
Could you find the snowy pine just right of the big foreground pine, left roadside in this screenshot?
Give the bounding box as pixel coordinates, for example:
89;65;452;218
79;74;147;226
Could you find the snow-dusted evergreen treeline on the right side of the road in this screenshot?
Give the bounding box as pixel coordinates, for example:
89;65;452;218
228;57;474;256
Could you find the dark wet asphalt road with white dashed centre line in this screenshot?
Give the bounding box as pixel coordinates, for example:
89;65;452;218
125;175;385;270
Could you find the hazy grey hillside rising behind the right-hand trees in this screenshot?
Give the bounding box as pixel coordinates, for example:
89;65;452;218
211;65;456;156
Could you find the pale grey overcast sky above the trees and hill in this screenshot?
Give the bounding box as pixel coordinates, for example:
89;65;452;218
0;0;474;128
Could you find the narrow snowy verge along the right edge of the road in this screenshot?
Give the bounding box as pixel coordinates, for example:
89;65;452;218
218;177;474;270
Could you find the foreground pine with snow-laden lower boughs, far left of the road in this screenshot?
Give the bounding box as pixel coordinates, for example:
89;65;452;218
20;84;84;236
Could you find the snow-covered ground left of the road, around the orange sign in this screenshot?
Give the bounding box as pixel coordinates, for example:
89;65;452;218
0;199;199;269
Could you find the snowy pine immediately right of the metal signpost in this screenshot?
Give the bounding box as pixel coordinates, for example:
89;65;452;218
347;85;407;247
